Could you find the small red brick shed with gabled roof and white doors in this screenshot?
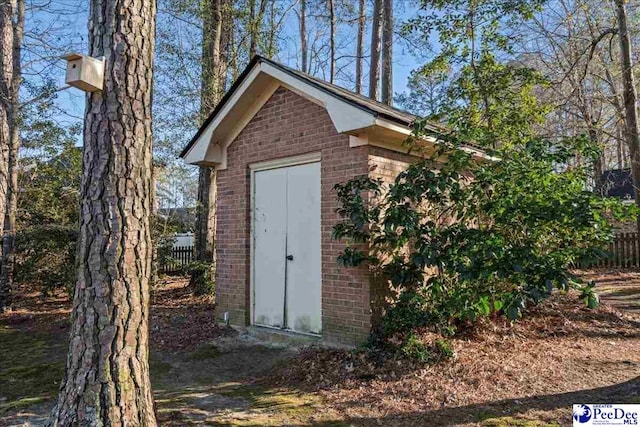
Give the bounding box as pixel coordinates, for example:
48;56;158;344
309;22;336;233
181;57;484;345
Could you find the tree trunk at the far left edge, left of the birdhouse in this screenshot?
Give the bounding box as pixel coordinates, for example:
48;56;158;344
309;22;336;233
0;0;25;312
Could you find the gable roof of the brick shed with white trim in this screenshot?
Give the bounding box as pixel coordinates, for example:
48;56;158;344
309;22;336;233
180;56;491;169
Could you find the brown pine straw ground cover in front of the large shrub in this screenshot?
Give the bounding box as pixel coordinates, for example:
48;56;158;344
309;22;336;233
267;280;640;426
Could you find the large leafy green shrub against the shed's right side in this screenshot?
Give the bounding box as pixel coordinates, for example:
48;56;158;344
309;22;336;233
333;139;635;344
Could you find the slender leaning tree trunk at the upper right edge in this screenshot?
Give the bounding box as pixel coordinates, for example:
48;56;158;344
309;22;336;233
616;0;640;232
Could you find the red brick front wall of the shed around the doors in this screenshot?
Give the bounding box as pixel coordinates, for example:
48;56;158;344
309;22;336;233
216;88;371;344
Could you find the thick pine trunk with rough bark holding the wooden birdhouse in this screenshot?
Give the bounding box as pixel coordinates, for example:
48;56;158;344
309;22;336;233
49;0;157;426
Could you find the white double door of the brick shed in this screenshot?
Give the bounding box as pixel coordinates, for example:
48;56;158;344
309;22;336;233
253;162;322;334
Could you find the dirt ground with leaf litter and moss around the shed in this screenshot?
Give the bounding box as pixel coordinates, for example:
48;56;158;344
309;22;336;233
0;271;640;427
